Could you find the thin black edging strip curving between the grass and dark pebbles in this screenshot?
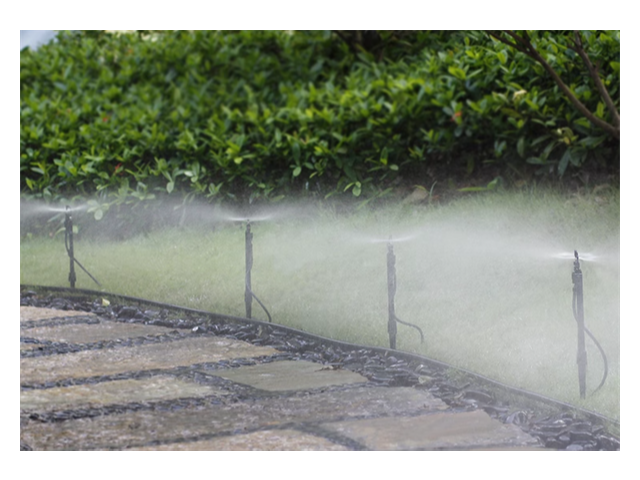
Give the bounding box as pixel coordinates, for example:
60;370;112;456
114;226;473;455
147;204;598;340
20;284;620;437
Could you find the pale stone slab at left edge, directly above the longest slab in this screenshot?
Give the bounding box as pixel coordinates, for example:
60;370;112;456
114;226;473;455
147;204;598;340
20;375;228;412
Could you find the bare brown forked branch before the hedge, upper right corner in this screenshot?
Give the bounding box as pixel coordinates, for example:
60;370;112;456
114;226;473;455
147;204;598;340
485;30;620;140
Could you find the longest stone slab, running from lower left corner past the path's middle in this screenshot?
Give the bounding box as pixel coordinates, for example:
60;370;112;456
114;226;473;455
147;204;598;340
21;384;450;450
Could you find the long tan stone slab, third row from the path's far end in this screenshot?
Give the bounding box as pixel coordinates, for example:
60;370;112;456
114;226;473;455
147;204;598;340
20;337;277;383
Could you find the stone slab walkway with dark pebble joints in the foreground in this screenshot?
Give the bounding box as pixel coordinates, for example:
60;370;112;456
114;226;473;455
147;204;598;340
20;307;552;451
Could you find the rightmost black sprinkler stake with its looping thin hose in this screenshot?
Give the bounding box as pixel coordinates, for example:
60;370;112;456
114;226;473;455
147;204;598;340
571;250;609;398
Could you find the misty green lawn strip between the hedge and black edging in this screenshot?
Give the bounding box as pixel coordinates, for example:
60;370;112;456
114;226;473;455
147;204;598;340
20;189;620;419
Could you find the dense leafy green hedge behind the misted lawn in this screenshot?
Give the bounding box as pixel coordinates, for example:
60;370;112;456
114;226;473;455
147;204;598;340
20;30;620;201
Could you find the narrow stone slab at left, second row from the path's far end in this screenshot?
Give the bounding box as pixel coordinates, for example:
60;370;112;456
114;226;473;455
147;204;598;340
24;320;173;344
